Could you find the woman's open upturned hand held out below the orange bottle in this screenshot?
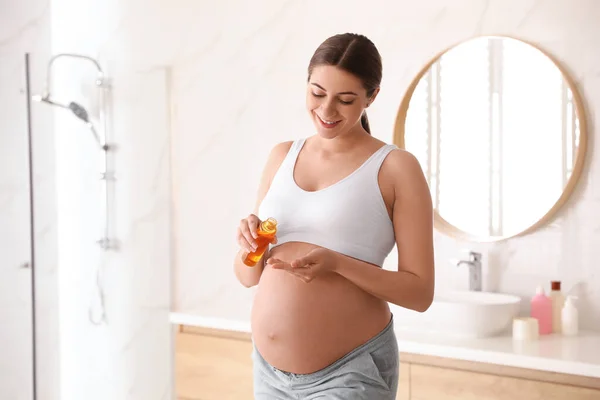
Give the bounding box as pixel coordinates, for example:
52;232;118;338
267;247;335;283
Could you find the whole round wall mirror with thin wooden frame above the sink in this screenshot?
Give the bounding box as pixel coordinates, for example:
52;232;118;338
395;37;587;241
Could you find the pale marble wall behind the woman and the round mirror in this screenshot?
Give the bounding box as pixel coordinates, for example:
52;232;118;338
169;0;600;329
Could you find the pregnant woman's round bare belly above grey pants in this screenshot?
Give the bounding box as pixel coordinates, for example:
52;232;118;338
252;242;391;374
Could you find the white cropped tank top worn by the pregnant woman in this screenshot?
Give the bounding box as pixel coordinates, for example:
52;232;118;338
258;139;397;267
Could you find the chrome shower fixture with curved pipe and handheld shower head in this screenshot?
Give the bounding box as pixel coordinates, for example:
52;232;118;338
32;53;117;250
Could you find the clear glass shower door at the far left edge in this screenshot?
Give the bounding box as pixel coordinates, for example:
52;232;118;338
0;52;34;400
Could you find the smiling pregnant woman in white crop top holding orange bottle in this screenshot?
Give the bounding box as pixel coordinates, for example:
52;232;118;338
234;33;434;400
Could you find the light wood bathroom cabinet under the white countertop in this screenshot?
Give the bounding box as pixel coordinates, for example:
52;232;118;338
175;326;600;400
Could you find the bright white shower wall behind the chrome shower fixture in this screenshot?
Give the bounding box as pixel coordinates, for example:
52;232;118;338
48;0;172;400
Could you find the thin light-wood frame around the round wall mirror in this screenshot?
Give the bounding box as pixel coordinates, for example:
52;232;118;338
393;35;588;243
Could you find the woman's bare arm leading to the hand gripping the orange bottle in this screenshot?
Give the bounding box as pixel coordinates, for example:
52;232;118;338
233;142;292;287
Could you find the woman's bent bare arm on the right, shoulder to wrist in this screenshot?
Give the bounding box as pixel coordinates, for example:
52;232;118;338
332;150;435;312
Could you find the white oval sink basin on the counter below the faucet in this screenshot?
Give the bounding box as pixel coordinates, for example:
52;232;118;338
391;291;521;338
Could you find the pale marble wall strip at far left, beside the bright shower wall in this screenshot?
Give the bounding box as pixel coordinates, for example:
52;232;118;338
0;0;59;400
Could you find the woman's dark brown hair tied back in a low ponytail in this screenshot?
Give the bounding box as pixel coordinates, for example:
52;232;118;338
308;33;383;133
